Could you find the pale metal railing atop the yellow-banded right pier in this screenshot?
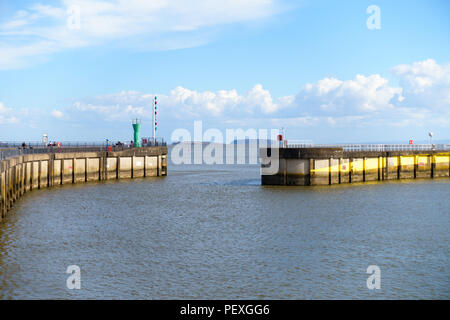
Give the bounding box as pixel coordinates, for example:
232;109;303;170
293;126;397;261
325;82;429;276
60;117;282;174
287;141;450;151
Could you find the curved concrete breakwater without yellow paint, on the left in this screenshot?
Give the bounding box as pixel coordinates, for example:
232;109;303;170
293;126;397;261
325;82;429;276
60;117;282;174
0;146;167;221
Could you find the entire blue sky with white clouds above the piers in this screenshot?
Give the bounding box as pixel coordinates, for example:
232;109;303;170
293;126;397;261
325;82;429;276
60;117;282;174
0;0;450;143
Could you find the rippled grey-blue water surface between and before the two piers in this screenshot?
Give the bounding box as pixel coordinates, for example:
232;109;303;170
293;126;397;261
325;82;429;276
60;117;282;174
0;159;450;299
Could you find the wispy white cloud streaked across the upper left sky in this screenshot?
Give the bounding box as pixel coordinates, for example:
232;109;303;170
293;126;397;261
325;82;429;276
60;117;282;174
0;0;280;69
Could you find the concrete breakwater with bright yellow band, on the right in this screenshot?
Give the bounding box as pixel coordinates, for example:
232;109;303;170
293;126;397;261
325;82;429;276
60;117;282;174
260;147;450;186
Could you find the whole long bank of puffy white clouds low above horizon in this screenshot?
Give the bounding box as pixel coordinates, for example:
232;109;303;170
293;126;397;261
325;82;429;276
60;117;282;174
0;60;450;136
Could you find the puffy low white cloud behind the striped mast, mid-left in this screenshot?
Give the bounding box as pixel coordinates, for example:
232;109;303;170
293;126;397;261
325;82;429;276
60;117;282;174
67;84;294;121
